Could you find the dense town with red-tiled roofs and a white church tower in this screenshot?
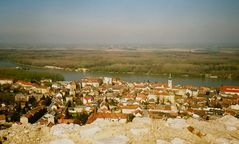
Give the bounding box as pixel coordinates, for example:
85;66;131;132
0;75;239;129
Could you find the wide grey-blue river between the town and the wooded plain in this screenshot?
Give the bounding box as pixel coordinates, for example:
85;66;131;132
0;60;239;86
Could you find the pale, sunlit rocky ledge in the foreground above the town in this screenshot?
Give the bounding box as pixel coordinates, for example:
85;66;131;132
0;116;239;144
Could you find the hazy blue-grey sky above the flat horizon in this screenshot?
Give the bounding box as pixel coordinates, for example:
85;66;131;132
0;0;239;43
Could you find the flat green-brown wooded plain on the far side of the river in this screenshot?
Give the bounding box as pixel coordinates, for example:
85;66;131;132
0;48;239;78
